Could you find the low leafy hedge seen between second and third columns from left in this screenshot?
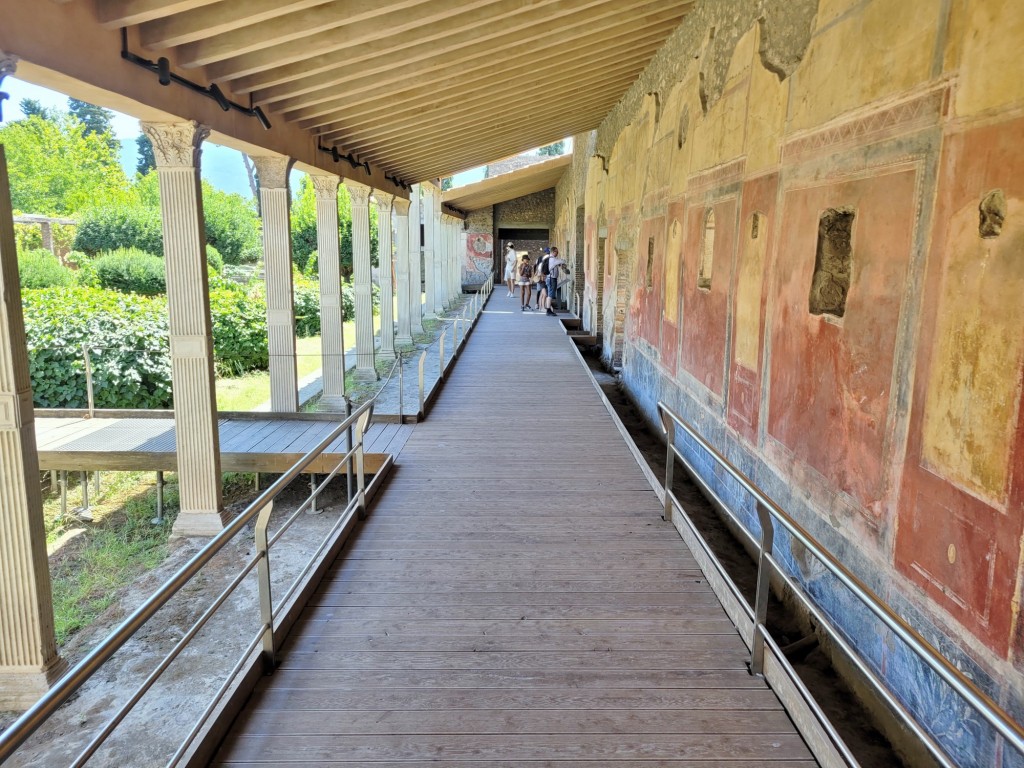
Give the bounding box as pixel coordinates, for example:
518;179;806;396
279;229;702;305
210;287;269;376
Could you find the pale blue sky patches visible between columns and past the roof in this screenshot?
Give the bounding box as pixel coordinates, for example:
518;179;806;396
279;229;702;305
3;77;524;197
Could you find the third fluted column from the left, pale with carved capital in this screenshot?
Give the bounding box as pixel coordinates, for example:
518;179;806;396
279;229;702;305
252;156;299;413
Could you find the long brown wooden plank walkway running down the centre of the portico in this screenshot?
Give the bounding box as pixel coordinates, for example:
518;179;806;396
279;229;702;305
214;292;814;768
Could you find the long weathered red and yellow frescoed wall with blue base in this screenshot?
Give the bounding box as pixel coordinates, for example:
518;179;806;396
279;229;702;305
556;0;1024;766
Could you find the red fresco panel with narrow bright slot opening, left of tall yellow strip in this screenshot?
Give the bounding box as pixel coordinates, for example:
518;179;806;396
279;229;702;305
679;198;736;397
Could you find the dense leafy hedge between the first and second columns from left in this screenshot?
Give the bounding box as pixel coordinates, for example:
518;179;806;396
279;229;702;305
22;288;171;409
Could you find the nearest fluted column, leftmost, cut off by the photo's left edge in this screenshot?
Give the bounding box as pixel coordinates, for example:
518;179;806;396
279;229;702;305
0;140;67;710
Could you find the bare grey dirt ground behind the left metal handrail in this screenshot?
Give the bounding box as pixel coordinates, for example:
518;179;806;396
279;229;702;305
0;477;345;768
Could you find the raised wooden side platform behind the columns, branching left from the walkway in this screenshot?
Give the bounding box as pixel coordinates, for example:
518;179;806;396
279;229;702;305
36;411;414;473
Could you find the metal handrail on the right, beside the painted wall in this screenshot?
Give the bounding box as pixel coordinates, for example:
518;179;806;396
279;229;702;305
657;400;1024;766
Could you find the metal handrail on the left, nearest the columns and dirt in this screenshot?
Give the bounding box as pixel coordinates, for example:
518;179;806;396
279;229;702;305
0;399;374;765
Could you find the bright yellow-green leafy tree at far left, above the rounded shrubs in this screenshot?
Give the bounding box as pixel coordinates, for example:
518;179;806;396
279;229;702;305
0;114;130;214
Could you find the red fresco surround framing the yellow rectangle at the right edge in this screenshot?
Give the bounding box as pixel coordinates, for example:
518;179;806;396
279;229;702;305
895;119;1024;667
